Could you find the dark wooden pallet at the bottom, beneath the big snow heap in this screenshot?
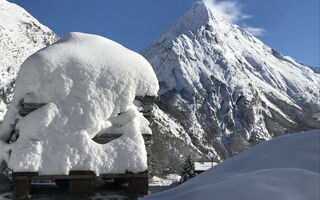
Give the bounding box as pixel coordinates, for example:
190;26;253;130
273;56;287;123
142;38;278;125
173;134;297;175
12;171;148;198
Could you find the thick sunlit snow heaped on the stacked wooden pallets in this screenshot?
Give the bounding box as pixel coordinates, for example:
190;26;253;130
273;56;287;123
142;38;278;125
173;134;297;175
0;33;159;174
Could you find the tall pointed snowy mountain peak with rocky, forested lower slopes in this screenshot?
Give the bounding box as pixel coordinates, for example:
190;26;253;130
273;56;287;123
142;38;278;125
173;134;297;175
142;3;320;171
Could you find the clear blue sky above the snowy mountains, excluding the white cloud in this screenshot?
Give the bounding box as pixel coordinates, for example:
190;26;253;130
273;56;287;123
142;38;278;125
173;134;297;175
9;0;320;66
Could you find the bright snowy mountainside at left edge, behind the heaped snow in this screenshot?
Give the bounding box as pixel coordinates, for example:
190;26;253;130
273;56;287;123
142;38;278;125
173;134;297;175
0;0;58;121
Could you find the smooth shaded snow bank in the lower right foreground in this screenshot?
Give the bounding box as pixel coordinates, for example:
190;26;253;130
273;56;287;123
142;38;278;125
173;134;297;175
144;130;320;200
